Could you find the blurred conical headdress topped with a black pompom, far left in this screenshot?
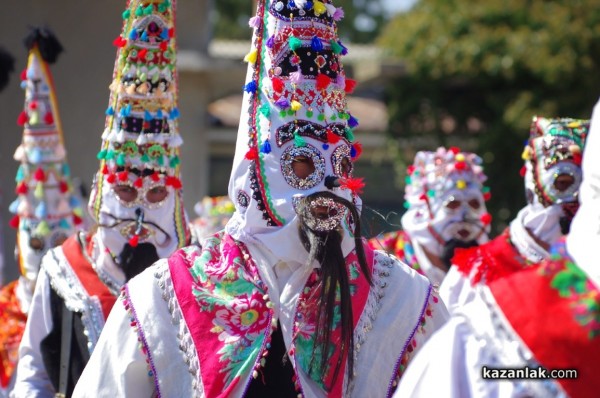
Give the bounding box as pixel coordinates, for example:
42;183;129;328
10;29;83;280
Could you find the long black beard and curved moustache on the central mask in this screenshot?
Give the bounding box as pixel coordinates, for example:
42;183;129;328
299;192;372;390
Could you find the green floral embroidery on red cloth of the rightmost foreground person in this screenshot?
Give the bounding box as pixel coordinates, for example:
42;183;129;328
540;241;600;340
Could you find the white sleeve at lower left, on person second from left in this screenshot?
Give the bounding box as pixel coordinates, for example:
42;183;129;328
10;271;54;398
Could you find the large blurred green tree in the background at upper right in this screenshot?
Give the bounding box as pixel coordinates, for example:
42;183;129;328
379;0;600;232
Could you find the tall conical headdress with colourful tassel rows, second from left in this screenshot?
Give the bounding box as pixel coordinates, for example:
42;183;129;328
89;0;189;256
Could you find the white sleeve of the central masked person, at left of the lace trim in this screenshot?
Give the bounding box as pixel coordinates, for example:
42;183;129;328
73;298;155;398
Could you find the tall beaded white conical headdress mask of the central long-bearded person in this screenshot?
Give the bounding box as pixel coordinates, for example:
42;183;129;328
228;0;362;260
